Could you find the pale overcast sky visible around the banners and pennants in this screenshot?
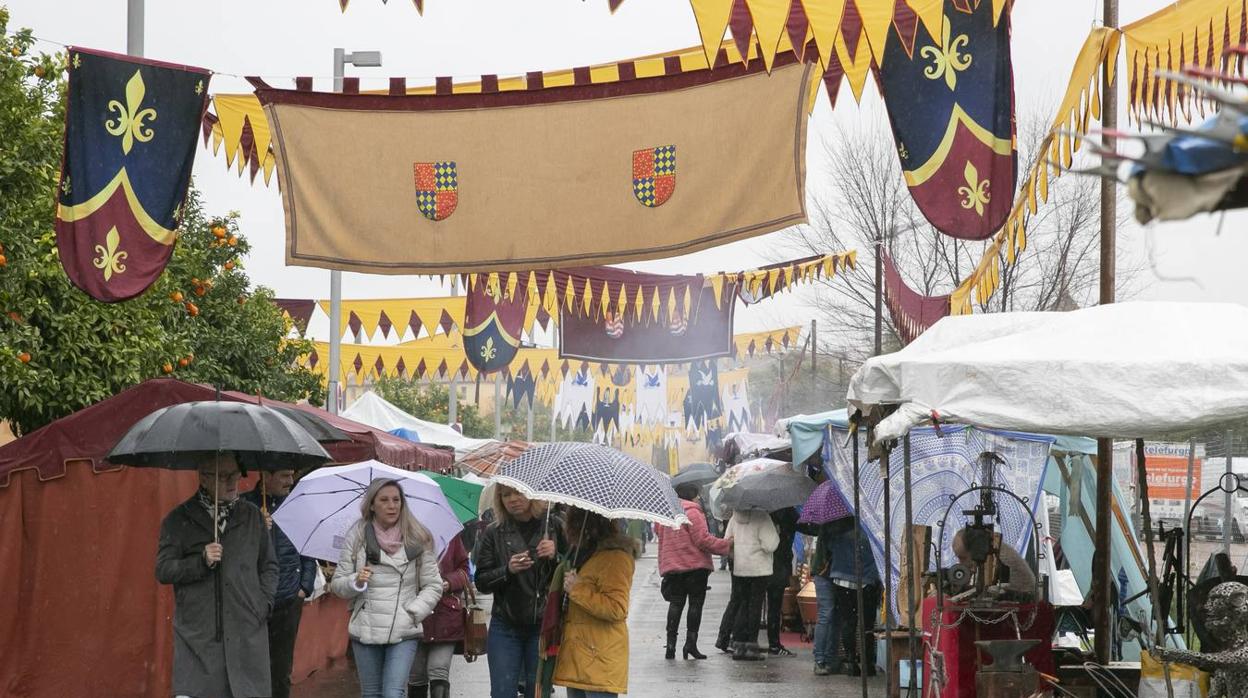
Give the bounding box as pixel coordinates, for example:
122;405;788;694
7;0;1248;344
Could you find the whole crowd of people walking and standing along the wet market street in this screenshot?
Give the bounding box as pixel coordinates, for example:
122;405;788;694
156;455;880;698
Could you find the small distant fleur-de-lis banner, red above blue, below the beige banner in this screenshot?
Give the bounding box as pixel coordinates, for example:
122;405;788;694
463;273;529;373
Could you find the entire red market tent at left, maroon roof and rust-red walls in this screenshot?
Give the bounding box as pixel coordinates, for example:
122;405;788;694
0;378;453;698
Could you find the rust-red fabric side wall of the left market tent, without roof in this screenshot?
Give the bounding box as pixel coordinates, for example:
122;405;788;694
0;465;347;698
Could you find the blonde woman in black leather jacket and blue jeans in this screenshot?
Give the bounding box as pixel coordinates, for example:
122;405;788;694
473;484;560;698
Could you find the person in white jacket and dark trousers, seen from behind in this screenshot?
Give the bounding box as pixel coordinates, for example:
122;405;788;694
724;511;780;661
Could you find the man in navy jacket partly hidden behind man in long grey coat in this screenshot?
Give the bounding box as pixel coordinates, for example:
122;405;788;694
242;469;316;698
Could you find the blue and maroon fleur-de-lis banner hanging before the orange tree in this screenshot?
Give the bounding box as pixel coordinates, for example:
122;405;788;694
56;47;211;302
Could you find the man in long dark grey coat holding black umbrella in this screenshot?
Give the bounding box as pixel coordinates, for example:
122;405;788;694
156;453;277;698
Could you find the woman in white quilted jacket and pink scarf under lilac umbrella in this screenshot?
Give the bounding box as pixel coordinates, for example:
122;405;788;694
329;478;442;698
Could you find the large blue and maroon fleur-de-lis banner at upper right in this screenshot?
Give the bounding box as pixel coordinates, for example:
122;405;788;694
879;0;1018;240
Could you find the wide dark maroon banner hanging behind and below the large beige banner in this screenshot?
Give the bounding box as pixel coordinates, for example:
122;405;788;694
559;287;735;363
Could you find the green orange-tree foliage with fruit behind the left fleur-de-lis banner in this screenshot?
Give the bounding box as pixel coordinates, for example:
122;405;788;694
0;7;323;433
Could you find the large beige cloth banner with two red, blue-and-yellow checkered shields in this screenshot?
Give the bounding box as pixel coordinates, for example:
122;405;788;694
253;52;812;273
